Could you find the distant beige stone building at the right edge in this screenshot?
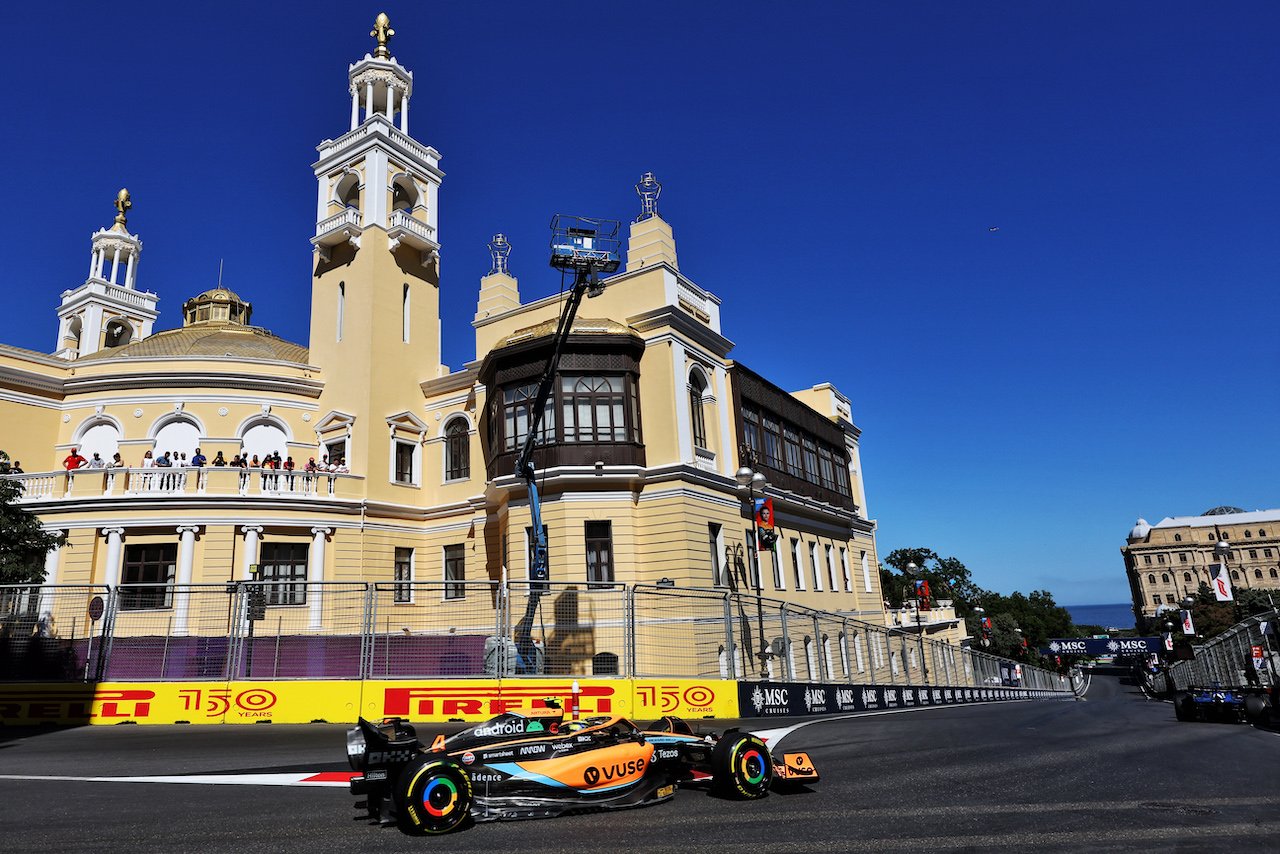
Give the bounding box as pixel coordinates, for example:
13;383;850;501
1120;507;1280;617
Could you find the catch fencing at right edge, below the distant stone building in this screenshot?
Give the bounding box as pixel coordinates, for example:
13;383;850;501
1152;611;1280;693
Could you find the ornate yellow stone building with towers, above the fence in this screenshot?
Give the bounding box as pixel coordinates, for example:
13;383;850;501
0;16;931;670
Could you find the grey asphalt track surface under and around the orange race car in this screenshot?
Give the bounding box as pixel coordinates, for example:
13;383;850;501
0;676;1280;854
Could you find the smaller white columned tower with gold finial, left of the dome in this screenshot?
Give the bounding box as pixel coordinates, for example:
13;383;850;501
55;189;160;359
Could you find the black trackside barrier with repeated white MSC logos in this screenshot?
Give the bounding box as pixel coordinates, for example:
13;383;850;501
737;682;1074;717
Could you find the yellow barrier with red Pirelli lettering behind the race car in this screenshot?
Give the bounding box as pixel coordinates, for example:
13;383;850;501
0;676;739;726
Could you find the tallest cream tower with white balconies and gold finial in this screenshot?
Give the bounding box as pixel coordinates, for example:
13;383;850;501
310;14;444;483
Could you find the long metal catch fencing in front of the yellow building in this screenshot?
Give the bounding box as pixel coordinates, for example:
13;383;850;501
0;581;1070;691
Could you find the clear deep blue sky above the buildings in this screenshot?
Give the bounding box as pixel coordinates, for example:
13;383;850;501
0;6;1280;604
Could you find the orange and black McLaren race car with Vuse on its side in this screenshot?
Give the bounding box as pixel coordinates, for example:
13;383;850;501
347;708;818;835
